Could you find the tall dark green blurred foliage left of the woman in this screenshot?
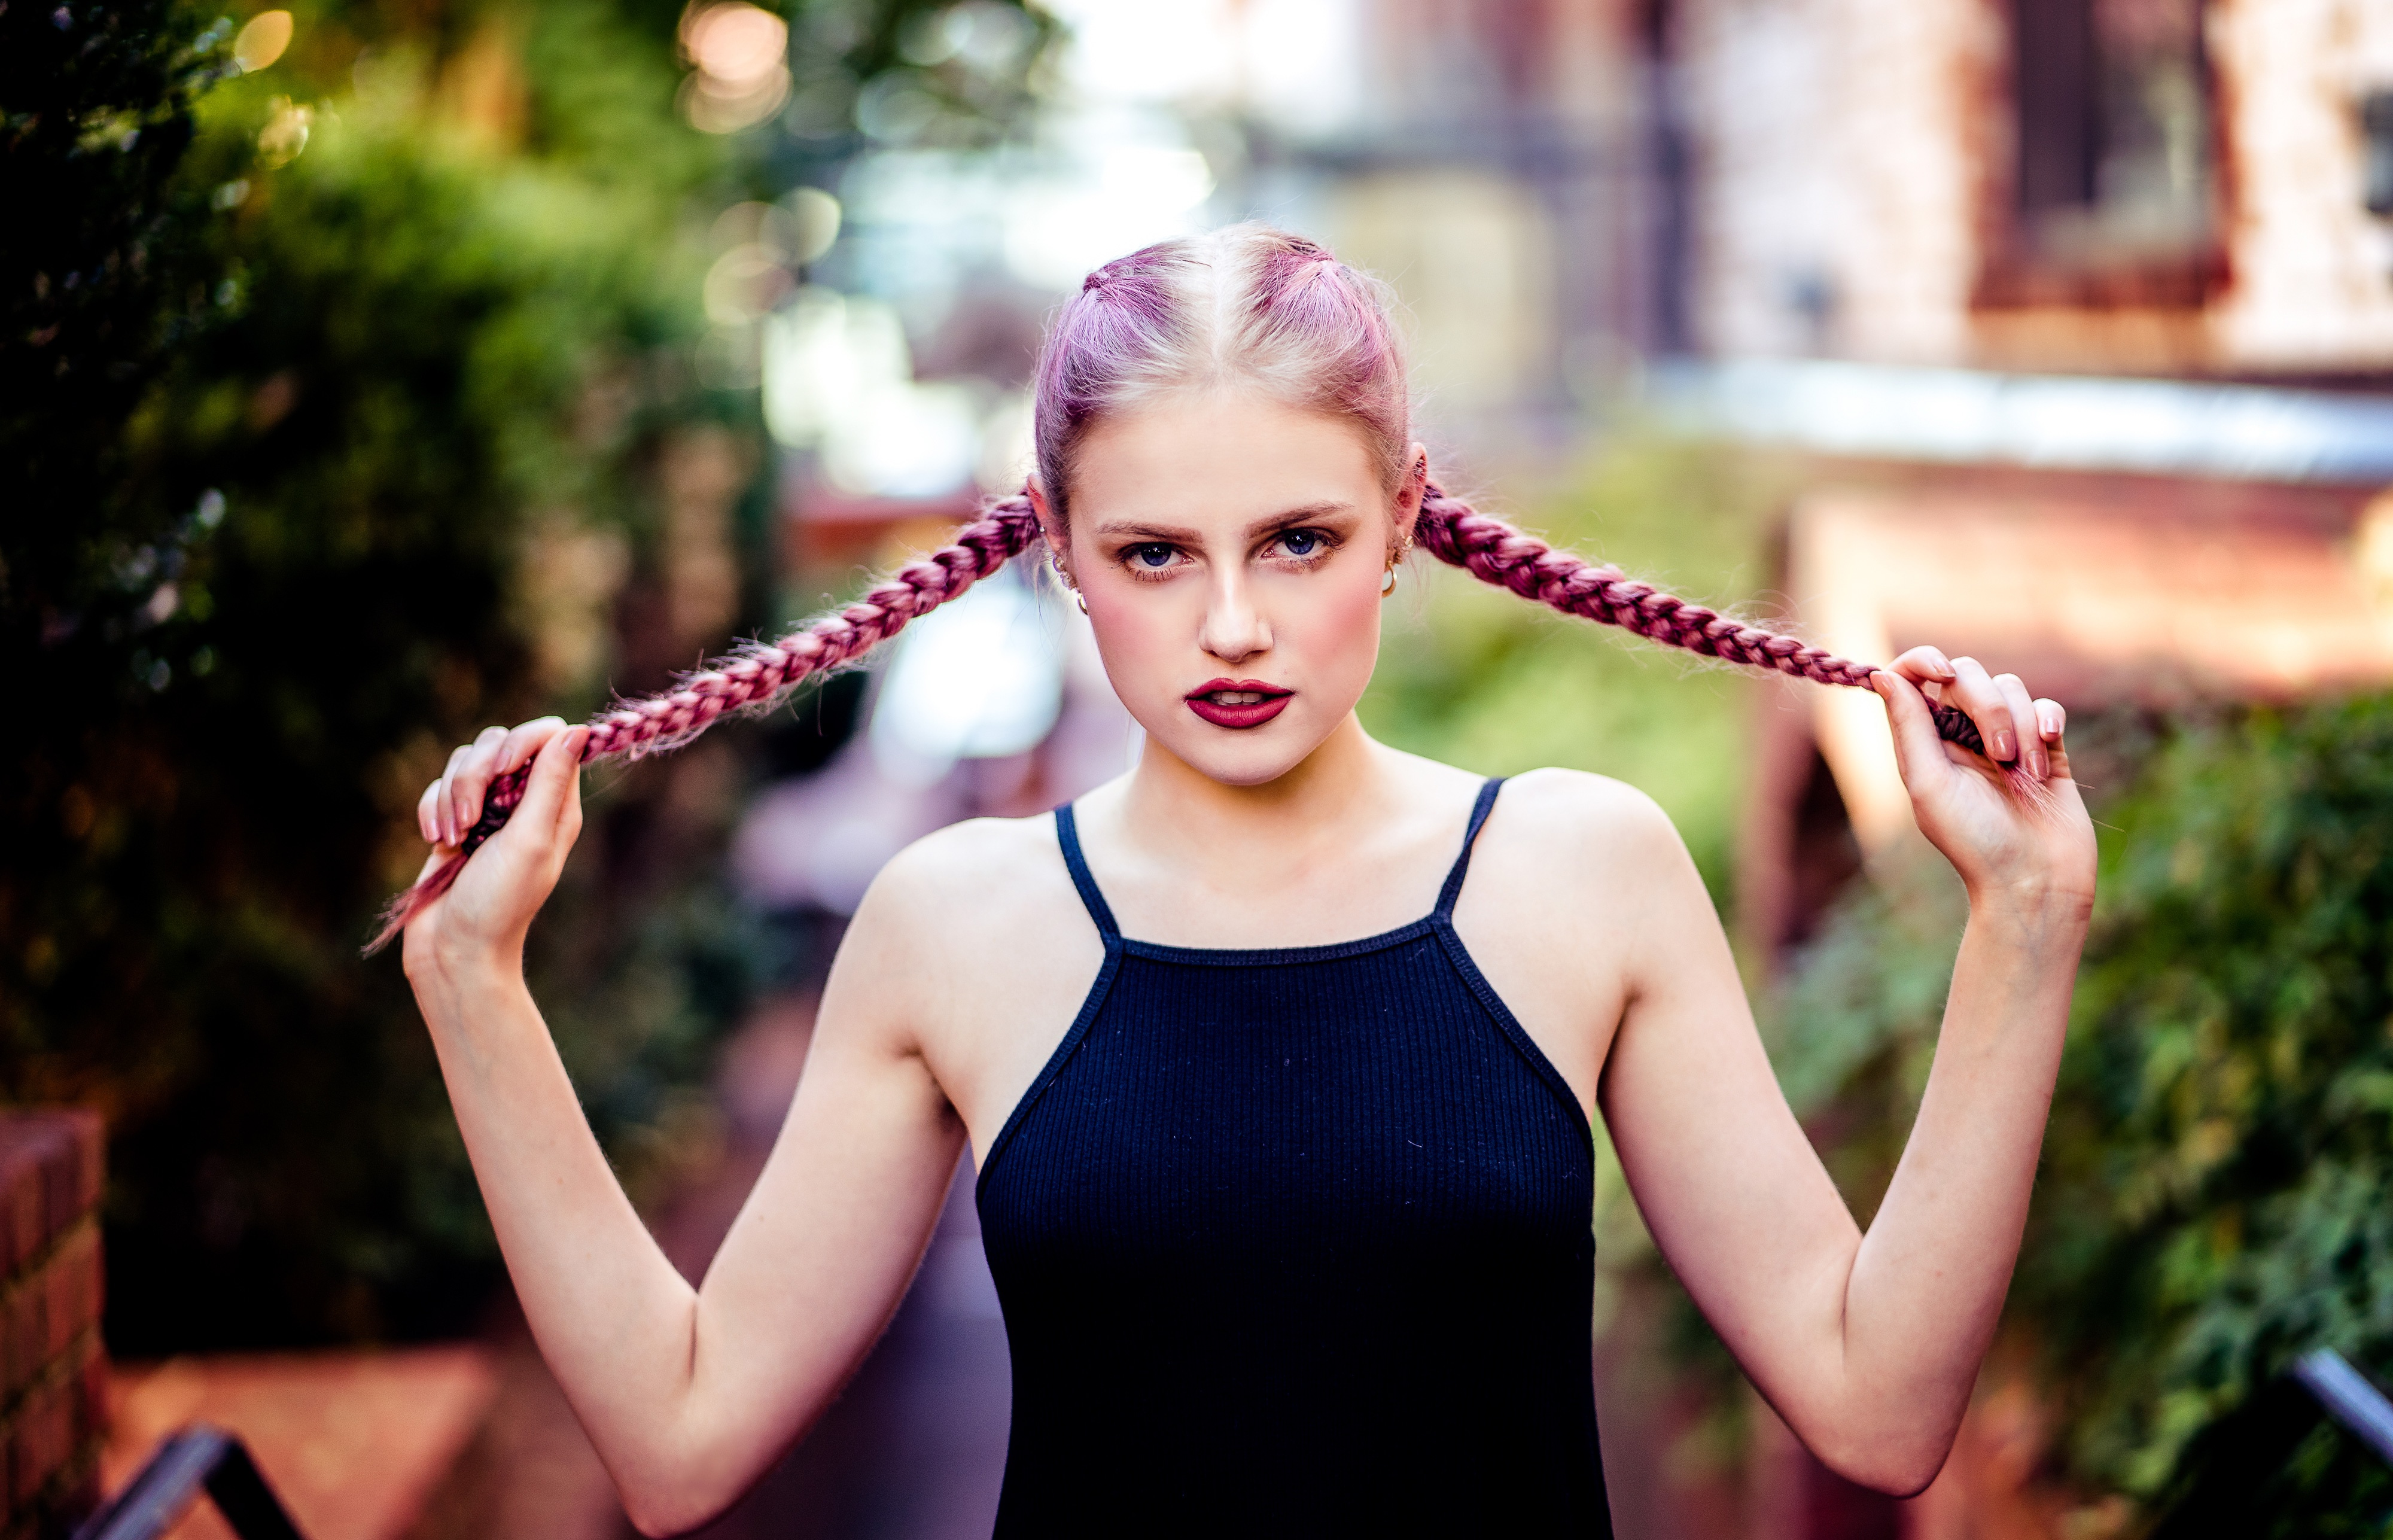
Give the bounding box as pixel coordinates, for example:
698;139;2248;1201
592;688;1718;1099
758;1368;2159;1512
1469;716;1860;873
0;0;1048;1356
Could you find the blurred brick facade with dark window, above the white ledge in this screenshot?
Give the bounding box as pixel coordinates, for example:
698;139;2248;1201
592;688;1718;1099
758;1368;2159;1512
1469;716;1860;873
1670;0;2393;378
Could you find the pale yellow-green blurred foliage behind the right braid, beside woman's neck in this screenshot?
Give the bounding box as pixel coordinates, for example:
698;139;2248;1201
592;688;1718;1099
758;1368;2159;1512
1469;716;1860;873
1362;428;1797;904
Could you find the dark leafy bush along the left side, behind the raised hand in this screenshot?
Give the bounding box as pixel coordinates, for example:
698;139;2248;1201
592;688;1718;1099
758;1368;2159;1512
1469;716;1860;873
0;7;756;1353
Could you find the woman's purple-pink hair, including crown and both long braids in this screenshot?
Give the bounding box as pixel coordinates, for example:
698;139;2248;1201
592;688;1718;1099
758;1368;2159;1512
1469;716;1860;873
366;225;1984;954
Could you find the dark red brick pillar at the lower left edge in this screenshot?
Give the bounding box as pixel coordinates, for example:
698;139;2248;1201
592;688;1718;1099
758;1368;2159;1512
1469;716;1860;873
0;1110;108;1540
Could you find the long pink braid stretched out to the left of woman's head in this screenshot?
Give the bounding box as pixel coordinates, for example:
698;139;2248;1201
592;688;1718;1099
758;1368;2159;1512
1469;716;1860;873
366;488;1039;957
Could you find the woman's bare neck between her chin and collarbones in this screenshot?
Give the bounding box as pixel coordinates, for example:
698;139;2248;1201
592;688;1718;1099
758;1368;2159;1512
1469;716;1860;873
1120;713;1402;887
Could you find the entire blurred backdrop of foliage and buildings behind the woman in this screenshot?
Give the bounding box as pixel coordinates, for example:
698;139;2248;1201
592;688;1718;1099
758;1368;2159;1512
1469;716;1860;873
14;0;2393;1540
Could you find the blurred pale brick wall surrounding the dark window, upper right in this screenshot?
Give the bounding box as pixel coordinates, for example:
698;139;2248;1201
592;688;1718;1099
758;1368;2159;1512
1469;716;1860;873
1675;0;2393;376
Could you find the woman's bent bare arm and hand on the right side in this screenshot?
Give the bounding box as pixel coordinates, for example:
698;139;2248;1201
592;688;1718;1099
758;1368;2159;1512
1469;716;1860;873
1601;648;2094;1492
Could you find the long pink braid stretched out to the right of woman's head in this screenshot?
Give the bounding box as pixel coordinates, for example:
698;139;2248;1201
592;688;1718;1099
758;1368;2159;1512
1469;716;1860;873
1417;485;1986;753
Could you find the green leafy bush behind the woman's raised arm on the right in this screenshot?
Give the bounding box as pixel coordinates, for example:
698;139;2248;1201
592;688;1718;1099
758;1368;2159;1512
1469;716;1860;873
1773;696;2393;1535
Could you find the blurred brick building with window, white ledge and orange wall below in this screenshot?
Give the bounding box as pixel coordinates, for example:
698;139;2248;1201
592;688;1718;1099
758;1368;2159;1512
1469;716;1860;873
1656;0;2393;970
